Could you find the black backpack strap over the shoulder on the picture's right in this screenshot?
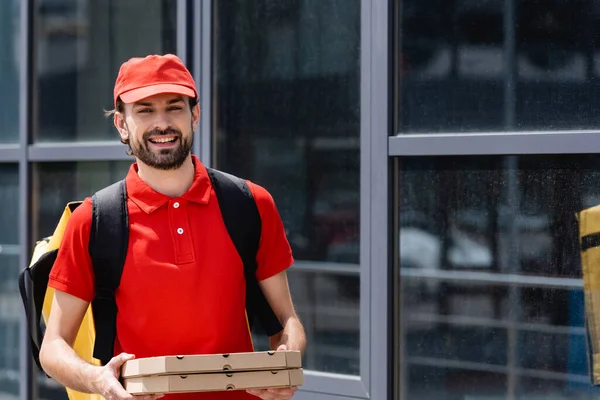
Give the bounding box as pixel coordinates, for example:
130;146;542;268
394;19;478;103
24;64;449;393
206;168;283;336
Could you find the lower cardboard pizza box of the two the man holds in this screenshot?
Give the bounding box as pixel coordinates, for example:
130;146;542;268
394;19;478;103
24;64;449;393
123;368;304;395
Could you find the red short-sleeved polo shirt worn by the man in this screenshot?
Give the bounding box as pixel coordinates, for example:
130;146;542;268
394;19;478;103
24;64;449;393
49;156;293;399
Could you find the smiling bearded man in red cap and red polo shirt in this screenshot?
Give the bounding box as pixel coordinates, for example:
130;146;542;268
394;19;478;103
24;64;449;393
40;55;306;400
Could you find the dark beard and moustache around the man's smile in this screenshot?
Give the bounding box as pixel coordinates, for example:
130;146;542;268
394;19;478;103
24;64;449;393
130;123;194;171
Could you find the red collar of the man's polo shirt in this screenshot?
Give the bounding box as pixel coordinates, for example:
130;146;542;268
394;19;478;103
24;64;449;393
125;154;211;214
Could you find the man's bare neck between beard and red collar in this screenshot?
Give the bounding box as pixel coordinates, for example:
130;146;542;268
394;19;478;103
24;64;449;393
137;156;195;197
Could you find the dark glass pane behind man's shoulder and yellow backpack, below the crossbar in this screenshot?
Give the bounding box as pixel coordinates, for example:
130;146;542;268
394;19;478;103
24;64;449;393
33;161;133;400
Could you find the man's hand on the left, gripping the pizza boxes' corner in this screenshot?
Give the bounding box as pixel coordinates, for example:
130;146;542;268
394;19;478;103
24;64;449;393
93;353;164;400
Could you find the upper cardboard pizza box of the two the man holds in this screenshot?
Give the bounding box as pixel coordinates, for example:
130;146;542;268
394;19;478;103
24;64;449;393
121;350;302;378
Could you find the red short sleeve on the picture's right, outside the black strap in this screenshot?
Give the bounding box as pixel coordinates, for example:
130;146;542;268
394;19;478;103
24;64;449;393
248;182;294;281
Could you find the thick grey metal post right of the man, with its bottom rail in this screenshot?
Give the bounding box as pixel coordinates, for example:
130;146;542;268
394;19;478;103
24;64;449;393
299;0;394;399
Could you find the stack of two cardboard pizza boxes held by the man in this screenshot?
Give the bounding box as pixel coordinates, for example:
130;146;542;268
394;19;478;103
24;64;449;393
121;351;304;395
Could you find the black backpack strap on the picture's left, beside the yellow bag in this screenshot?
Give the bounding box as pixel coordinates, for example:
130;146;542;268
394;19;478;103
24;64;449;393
89;180;129;365
